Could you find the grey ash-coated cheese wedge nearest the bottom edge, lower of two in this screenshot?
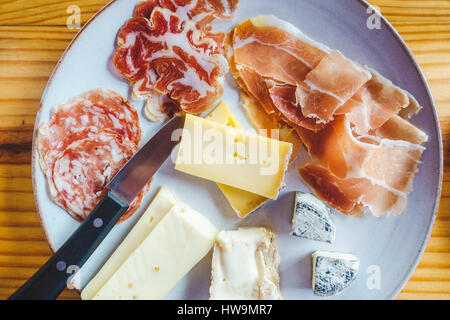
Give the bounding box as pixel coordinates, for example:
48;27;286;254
312;251;359;297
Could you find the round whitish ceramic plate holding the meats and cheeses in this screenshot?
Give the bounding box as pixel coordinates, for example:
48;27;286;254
32;0;442;299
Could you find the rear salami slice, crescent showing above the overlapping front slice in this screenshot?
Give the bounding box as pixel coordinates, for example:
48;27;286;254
38;89;142;190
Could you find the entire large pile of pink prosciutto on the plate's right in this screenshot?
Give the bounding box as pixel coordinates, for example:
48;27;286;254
226;16;427;216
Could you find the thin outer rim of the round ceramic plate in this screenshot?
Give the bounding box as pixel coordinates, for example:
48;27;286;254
31;0;444;300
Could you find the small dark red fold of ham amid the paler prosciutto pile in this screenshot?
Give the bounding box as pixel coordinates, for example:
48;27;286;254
269;85;324;132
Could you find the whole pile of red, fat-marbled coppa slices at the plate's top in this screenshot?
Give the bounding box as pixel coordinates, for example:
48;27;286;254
113;0;238;121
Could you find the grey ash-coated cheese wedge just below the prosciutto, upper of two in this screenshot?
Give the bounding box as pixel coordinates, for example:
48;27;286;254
292;192;336;243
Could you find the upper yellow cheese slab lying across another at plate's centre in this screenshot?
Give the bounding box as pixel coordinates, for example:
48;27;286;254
175;114;292;199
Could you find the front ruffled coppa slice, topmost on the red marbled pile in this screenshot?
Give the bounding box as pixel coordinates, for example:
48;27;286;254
114;7;228;114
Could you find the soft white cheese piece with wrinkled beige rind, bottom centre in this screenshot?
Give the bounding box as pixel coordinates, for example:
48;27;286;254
210;228;282;300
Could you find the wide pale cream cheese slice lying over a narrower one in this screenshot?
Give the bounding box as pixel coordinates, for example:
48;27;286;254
93;202;218;300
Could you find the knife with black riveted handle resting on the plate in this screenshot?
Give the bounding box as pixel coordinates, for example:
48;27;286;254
8;117;184;300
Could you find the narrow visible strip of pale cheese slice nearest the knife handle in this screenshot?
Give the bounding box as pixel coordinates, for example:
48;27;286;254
81;186;178;300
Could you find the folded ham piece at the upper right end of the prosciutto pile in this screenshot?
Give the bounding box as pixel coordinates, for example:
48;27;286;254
348;72;409;135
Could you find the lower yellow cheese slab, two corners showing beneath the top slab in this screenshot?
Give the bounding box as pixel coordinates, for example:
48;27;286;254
206;102;269;218
